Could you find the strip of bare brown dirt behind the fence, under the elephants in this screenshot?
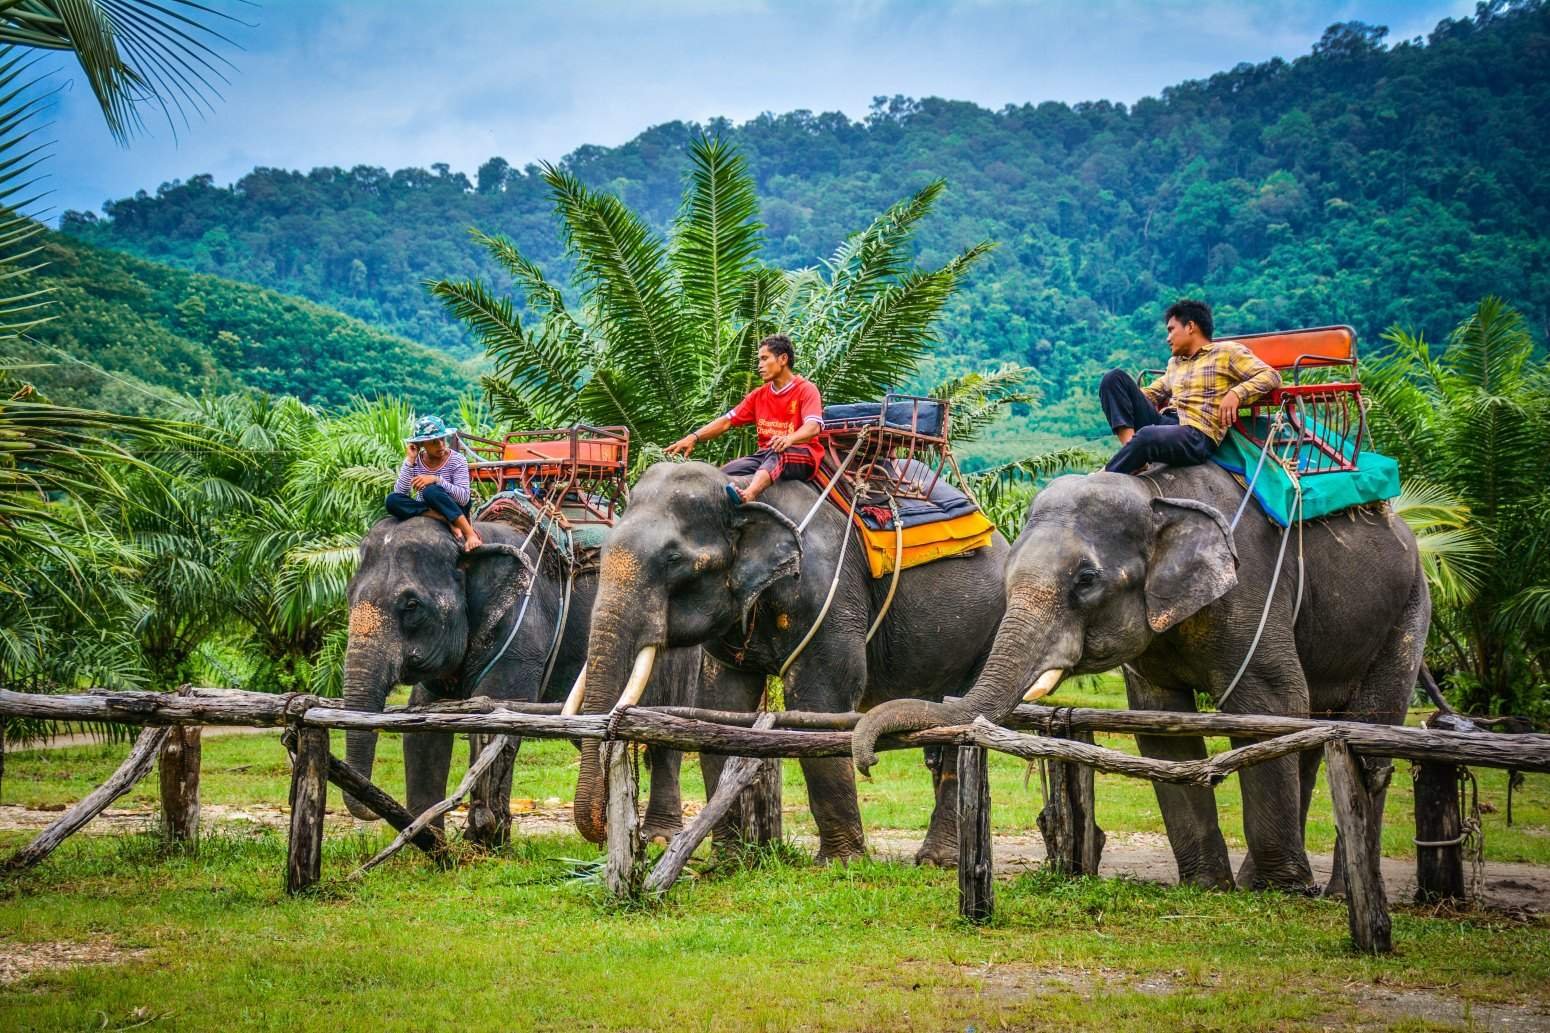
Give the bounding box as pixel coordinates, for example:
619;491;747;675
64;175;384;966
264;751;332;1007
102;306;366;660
0;797;1550;914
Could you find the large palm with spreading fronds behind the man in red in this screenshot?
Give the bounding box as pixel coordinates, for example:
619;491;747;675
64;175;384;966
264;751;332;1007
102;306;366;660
431;138;1004;459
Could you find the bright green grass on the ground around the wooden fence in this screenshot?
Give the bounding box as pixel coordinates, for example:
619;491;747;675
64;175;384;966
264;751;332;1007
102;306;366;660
0;673;1550;1033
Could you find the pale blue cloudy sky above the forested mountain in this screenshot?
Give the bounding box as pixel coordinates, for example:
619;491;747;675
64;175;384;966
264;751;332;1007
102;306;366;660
50;0;1474;216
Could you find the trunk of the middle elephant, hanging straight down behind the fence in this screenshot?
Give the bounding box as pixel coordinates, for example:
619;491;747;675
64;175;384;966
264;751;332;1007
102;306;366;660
574;593;662;842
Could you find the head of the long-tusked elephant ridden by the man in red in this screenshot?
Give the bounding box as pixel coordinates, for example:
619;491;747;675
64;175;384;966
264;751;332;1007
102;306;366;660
575;462;801;842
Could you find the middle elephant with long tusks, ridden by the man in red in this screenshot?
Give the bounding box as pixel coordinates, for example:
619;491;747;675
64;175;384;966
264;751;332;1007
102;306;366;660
575;462;1009;864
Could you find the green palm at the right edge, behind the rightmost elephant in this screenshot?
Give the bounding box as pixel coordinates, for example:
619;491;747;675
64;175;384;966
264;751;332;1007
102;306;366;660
1364;298;1550;712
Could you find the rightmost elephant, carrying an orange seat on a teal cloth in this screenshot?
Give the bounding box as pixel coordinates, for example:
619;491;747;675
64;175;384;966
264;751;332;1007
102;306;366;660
853;464;1431;893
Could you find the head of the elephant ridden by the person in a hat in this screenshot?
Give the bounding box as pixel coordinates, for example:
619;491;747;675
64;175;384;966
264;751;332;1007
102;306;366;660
344;517;530;819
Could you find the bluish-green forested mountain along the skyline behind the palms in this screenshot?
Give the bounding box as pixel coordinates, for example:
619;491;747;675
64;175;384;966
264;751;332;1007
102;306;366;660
62;0;1550;436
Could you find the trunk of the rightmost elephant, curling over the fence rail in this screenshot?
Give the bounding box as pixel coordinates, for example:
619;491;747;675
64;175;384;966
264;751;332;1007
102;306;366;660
851;602;1076;774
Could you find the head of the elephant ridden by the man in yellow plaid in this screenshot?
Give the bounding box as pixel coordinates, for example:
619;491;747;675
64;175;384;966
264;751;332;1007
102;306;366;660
851;473;1237;772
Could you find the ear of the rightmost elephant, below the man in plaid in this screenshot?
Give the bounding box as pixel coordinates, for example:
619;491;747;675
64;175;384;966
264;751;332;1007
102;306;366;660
1147;498;1238;634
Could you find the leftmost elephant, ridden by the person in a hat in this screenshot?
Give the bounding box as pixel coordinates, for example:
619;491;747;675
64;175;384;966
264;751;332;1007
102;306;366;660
344;517;699;842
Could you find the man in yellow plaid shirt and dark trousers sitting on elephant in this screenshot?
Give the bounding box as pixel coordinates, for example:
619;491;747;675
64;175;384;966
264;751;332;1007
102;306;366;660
1097;298;1280;473
